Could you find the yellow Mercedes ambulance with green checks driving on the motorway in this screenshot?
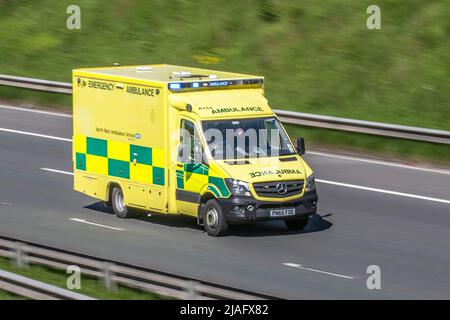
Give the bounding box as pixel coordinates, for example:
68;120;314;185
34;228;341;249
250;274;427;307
73;65;317;236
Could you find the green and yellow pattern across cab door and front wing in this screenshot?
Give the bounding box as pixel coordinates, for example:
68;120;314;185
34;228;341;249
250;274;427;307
176;163;230;198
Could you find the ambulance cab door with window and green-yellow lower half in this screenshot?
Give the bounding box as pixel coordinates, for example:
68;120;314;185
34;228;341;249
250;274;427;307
175;117;209;216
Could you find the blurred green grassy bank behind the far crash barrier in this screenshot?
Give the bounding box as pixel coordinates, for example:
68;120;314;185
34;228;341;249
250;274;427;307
0;0;450;159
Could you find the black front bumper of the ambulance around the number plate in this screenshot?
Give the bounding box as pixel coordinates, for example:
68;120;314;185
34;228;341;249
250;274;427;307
218;191;318;224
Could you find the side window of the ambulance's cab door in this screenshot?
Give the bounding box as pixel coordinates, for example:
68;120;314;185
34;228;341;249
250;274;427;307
178;119;203;163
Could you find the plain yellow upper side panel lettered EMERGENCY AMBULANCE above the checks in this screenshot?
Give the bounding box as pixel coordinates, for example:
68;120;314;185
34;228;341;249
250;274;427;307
74;75;167;154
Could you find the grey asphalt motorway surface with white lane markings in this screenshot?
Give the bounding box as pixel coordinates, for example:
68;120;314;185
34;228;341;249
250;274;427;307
0;106;450;299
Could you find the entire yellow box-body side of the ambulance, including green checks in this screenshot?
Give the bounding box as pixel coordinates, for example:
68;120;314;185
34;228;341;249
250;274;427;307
73;72;169;210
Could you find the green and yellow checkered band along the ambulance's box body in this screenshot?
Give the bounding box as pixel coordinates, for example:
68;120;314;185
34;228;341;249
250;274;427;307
74;136;165;186
